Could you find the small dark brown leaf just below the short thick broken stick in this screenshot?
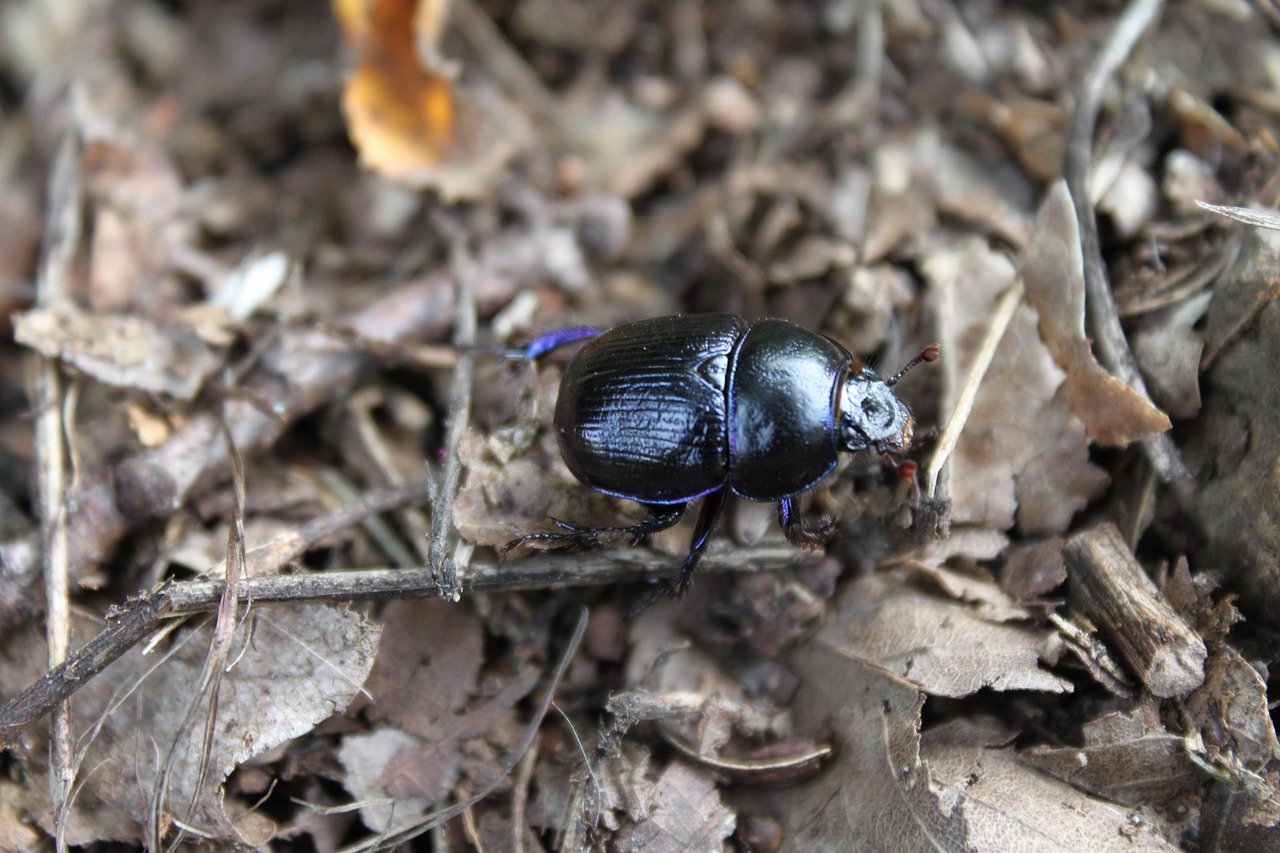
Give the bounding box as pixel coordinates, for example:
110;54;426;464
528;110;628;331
1024;702;1203;806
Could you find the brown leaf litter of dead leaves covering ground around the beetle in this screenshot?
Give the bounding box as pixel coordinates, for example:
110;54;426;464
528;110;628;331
0;0;1280;850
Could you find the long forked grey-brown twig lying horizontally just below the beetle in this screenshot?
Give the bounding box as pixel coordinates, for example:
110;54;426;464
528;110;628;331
0;537;798;747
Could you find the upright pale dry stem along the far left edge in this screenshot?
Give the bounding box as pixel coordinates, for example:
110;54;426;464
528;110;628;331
33;131;83;835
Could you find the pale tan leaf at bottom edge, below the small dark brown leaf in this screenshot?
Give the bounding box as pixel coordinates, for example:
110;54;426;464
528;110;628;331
920;720;1178;853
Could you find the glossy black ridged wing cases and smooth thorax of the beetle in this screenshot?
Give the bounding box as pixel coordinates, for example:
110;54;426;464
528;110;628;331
556;314;855;503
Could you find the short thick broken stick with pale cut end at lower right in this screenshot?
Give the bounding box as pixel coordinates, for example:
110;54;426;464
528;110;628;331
1062;523;1207;698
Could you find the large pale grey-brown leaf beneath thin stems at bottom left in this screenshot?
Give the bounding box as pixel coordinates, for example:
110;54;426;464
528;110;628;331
23;605;381;844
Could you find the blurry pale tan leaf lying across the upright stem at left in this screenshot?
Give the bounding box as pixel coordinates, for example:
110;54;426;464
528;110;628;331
14;305;221;400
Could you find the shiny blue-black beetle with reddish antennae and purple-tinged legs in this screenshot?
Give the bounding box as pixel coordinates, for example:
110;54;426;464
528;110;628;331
503;314;940;597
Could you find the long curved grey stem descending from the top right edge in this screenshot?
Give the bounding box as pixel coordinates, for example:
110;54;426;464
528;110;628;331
1062;0;1190;482
